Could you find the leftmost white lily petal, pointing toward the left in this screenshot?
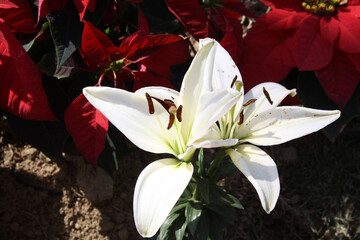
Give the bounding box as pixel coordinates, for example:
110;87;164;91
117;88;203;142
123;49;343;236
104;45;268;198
83;87;177;154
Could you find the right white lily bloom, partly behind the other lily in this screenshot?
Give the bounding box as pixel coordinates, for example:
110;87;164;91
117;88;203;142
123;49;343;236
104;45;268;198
194;40;340;213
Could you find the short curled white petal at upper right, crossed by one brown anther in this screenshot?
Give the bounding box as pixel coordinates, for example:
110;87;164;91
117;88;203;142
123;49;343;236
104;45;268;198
240;82;296;119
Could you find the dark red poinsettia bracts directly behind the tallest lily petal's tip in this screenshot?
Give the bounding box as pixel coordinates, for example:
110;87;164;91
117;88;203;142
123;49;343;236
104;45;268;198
165;0;254;63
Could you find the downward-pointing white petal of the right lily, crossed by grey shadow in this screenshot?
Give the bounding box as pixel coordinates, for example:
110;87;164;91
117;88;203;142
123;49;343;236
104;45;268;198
227;144;280;213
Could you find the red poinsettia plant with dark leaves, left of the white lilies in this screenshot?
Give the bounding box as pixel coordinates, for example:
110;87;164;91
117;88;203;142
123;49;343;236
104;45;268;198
0;0;194;169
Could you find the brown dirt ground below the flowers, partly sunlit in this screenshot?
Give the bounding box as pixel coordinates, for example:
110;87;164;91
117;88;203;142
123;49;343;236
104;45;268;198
0;117;360;240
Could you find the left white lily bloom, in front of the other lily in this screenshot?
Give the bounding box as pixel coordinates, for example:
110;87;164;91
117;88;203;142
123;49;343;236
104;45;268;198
83;41;242;237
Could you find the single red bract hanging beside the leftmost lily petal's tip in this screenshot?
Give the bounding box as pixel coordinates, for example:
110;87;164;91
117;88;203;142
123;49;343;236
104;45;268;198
64;94;109;166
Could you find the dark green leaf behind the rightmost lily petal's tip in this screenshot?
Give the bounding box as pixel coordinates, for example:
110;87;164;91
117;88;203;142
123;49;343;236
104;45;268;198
297;72;360;141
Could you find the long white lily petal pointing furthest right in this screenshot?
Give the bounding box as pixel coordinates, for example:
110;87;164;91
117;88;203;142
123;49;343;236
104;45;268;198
236;107;340;146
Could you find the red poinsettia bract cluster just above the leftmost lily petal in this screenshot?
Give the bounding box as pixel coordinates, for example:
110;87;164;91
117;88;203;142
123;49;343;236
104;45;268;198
80;21;189;90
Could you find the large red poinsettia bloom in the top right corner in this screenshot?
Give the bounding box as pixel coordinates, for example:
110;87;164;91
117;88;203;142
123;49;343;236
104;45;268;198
239;0;360;108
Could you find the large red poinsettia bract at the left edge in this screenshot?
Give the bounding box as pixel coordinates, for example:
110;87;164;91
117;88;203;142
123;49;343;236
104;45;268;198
0;19;55;121
